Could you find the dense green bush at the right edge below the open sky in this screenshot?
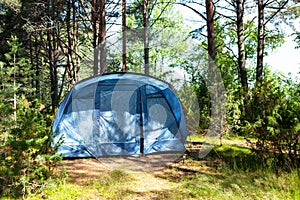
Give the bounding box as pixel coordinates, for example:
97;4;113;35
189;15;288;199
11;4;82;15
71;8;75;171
244;75;300;169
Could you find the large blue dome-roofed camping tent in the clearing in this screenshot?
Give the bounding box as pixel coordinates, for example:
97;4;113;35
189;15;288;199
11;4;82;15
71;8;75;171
52;73;187;157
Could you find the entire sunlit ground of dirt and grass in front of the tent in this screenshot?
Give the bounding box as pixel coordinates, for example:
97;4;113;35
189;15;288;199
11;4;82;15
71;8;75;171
29;139;300;199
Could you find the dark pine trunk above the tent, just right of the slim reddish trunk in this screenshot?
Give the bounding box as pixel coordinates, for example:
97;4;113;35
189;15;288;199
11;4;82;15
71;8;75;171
143;0;150;75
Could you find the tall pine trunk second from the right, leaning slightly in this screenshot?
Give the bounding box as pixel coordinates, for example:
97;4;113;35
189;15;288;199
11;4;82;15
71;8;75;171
236;0;248;94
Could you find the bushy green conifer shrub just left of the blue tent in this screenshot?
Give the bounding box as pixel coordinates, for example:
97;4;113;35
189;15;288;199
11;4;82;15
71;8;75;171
0;96;60;197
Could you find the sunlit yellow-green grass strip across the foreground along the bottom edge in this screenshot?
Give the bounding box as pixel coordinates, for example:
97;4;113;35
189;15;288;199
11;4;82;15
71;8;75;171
28;165;300;199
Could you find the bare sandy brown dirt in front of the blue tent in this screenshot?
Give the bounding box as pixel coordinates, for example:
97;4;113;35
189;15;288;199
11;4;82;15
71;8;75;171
57;141;250;199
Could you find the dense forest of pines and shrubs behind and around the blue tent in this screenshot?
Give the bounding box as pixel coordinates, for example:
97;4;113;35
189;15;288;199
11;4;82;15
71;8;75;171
0;0;300;197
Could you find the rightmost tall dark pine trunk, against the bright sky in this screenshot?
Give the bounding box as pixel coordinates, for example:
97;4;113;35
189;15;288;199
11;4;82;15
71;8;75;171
256;0;265;83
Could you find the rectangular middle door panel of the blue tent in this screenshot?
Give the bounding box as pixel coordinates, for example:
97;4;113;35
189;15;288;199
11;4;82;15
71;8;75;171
94;83;141;156
